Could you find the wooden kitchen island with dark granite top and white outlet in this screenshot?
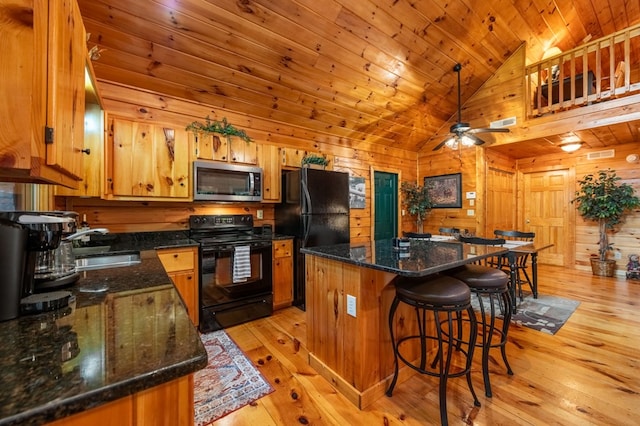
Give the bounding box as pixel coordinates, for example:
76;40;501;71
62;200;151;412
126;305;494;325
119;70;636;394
300;240;507;408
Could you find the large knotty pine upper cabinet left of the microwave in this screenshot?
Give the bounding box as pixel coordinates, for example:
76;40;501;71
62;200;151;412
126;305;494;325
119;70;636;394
105;116;191;201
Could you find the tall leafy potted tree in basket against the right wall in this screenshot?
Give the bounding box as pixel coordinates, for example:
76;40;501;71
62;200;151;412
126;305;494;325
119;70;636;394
571;169;640;276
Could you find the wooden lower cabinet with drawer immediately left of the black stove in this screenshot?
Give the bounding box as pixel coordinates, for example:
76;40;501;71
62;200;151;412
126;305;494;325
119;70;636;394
158;247;199;326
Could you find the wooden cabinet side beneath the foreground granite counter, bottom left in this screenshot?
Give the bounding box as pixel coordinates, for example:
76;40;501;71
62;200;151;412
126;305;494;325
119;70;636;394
48;374;194;426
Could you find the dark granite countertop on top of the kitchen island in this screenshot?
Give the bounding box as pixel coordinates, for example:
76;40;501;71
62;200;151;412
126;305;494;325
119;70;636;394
300;239;508;277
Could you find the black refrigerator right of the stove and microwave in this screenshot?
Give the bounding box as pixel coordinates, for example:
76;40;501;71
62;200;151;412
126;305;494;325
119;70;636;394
275;168;349;310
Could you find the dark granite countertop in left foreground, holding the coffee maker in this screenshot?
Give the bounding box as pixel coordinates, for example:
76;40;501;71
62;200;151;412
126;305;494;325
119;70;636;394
0;251;207;425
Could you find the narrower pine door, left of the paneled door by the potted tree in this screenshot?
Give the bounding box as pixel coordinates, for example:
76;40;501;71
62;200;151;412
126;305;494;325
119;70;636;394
484;167;516;238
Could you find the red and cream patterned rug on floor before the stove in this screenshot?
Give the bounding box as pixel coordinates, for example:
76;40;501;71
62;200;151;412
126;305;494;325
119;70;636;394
194;330;274;426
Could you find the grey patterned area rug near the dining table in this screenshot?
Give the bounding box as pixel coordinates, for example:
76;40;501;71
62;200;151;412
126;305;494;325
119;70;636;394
472;293;580;334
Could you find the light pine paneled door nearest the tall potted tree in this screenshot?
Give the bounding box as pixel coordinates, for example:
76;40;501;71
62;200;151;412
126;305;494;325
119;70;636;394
522;169;573;266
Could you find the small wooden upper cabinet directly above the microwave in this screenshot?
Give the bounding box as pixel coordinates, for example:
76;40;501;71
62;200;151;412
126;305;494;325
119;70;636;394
189;132;258;164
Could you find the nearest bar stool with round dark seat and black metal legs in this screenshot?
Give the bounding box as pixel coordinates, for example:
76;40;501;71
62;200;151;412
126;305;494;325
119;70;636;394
386;275;480;425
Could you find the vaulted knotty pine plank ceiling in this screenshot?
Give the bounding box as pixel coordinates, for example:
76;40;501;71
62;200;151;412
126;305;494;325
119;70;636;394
78;0;640;158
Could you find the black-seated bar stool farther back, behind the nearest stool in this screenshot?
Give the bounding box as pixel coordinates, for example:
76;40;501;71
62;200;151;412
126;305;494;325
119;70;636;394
446;236;513;398
